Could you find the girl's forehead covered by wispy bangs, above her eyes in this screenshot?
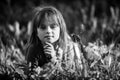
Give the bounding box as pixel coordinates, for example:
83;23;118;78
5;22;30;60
42;14;58;24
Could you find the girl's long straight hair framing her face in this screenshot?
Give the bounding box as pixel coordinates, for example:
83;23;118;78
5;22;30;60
25;6;70;53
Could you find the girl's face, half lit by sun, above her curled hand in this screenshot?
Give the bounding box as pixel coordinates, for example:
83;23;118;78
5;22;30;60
37;15;60;43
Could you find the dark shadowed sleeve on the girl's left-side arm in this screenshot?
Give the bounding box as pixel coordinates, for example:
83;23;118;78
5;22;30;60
27;45;47;67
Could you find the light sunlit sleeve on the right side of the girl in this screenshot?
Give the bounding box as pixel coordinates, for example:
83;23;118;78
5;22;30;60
63;42;83;75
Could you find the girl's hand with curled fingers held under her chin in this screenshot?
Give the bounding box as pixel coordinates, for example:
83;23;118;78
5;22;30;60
44;42;56;60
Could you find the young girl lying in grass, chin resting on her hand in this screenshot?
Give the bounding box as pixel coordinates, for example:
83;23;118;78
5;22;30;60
26;6;84;76
